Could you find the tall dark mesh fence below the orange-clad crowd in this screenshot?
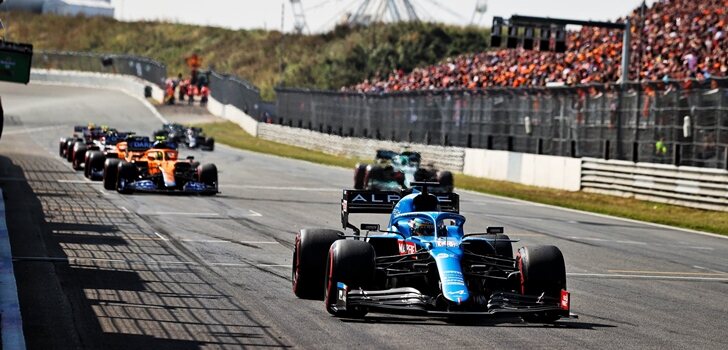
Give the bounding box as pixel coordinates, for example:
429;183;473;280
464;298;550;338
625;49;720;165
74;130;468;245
275;79;728;169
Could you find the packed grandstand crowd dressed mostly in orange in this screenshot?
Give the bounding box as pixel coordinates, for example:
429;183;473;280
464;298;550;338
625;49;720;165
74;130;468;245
350;0;728;92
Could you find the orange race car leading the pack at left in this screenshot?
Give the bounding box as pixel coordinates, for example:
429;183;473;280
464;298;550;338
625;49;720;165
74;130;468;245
103;142;218;195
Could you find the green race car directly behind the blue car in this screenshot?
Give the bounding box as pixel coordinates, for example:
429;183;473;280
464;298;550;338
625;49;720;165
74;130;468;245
354;150;454;193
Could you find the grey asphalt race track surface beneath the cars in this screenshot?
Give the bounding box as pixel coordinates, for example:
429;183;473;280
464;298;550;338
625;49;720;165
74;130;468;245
0;84;728;350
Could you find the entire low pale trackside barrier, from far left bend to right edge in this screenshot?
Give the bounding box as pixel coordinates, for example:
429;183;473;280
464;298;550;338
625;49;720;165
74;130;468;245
31;69;728;211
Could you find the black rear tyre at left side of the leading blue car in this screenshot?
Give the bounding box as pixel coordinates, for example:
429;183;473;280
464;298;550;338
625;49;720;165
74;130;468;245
291;229;344;300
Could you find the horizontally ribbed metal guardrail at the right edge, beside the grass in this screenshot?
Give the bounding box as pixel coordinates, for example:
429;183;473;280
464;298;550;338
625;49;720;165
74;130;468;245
581;158;728;211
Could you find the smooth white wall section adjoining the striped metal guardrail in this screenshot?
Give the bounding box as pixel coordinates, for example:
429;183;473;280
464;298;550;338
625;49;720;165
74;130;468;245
463;148;581;191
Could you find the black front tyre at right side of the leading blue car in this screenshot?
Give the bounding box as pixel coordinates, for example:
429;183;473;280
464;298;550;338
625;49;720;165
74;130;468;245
516;245;566;323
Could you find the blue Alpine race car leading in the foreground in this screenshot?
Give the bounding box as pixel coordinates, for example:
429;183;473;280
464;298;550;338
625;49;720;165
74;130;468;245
292;182;575;323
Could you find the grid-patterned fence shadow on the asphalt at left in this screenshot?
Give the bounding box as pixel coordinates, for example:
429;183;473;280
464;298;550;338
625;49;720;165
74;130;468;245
0;151;287;350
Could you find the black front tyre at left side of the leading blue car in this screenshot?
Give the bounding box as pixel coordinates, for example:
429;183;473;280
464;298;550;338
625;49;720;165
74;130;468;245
324;239;375;318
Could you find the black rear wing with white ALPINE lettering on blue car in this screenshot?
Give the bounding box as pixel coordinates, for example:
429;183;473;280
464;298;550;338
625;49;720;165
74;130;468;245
341;190;460;233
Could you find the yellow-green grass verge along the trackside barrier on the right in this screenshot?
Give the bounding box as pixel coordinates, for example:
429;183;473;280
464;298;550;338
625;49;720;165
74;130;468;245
198;122;728;235
